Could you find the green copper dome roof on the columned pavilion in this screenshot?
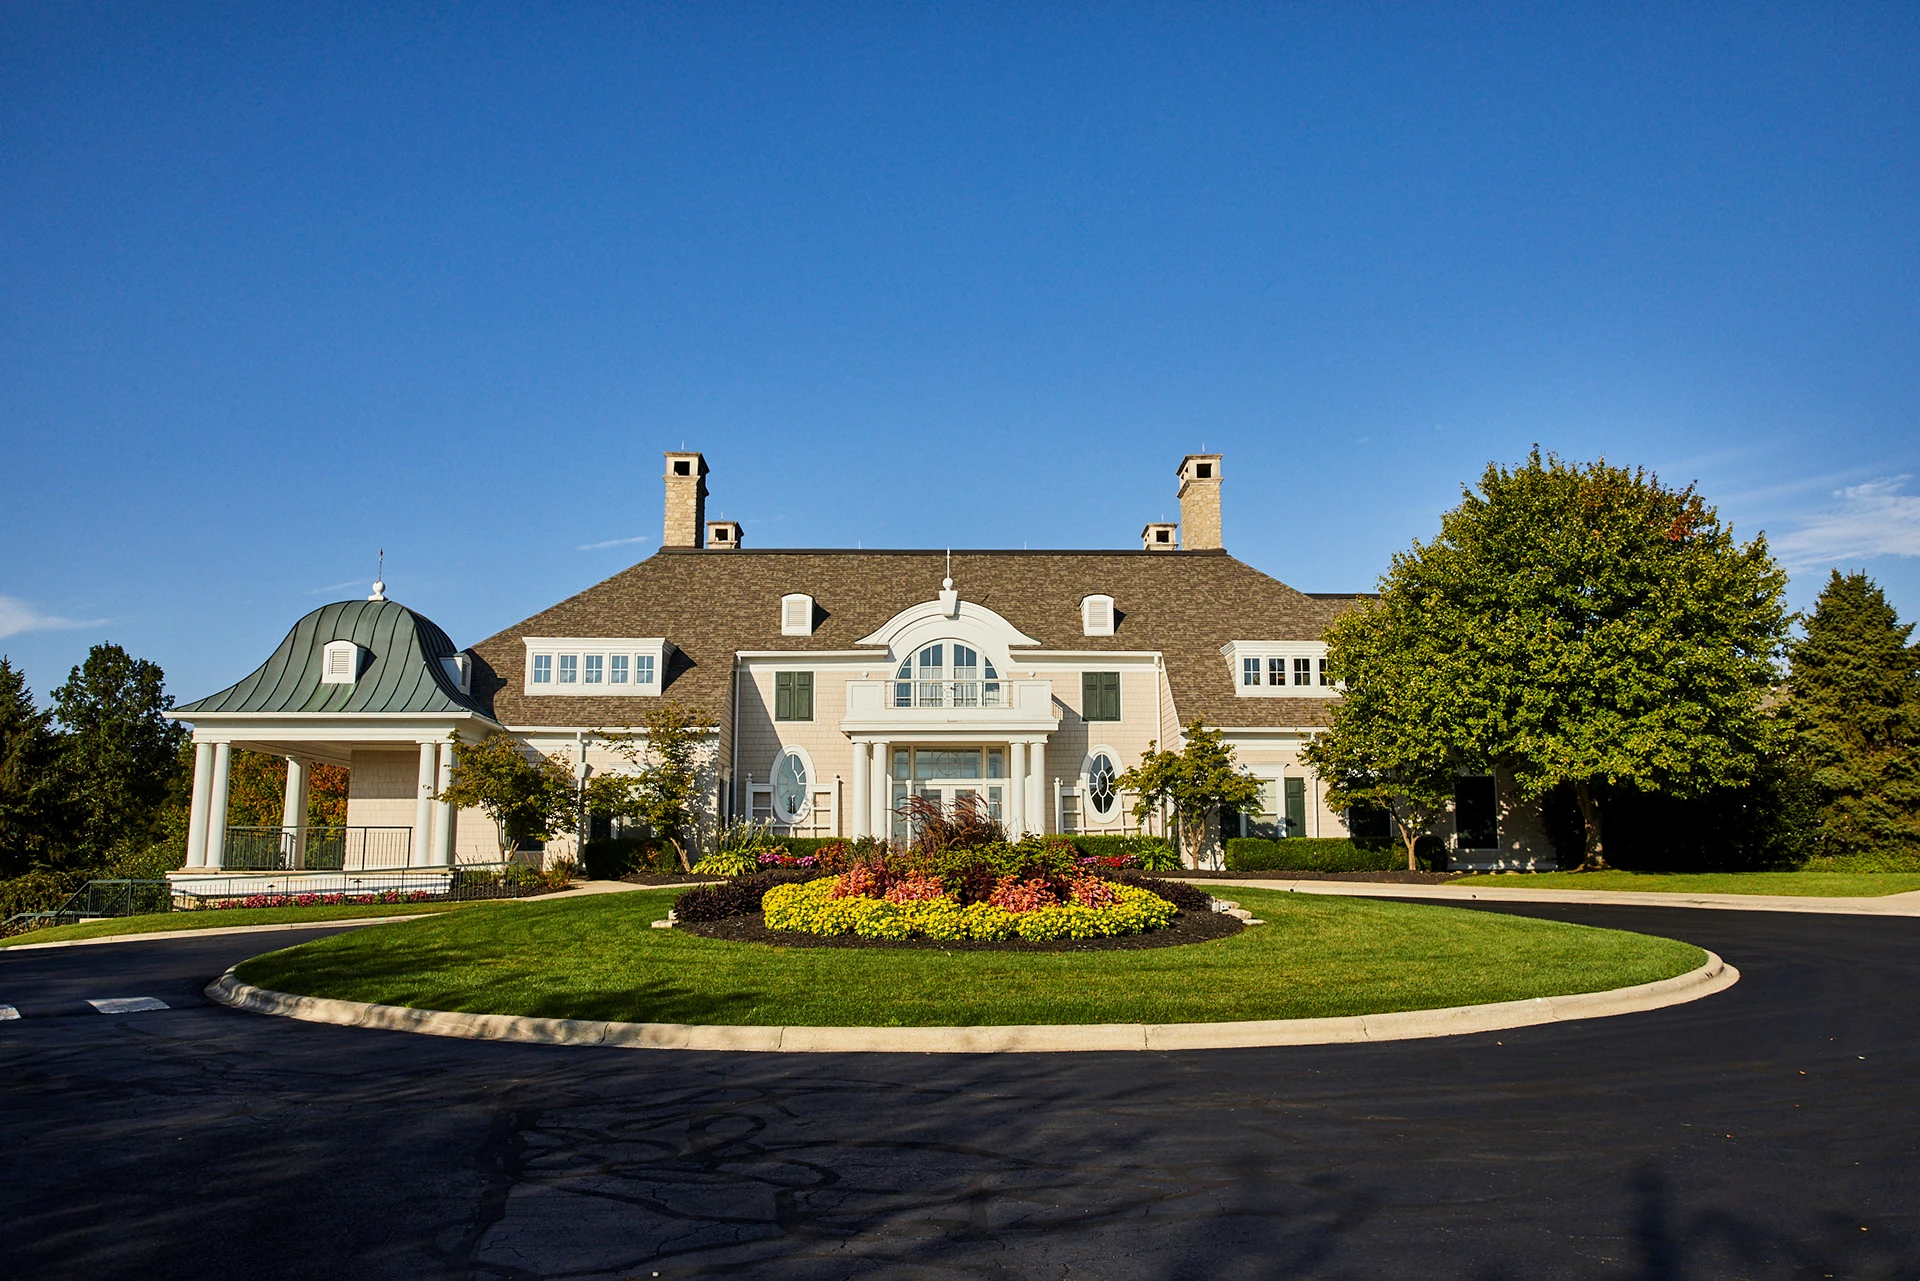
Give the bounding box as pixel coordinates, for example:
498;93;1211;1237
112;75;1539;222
175;601;488;718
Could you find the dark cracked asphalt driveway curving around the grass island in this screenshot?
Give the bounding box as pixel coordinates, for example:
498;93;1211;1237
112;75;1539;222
0;905;1920;1281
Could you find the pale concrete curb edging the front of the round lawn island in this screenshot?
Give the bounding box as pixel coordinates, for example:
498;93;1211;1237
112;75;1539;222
207;953;1740;1054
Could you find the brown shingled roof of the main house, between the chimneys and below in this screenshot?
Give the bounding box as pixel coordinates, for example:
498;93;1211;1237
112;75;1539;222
472;547;1356;728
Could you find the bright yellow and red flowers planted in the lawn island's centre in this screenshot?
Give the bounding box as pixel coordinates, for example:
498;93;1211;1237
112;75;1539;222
762;866;1177;943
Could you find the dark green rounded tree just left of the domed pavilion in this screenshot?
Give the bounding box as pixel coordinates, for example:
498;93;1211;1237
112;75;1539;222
54;643;186;864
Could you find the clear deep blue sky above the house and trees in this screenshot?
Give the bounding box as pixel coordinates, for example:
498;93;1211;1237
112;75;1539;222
0;0;1920;699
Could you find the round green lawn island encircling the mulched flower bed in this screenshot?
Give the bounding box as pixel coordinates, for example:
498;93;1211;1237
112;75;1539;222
240;889;1703;1026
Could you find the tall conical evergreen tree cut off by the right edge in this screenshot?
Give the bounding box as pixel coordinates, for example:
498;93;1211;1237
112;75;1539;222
1788;570;1920;857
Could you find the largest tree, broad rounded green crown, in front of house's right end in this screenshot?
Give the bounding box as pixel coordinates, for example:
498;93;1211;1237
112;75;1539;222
1329;449;1788;866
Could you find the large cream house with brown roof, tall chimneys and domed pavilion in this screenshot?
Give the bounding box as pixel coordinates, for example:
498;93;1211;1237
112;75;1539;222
161;453;1549;891
